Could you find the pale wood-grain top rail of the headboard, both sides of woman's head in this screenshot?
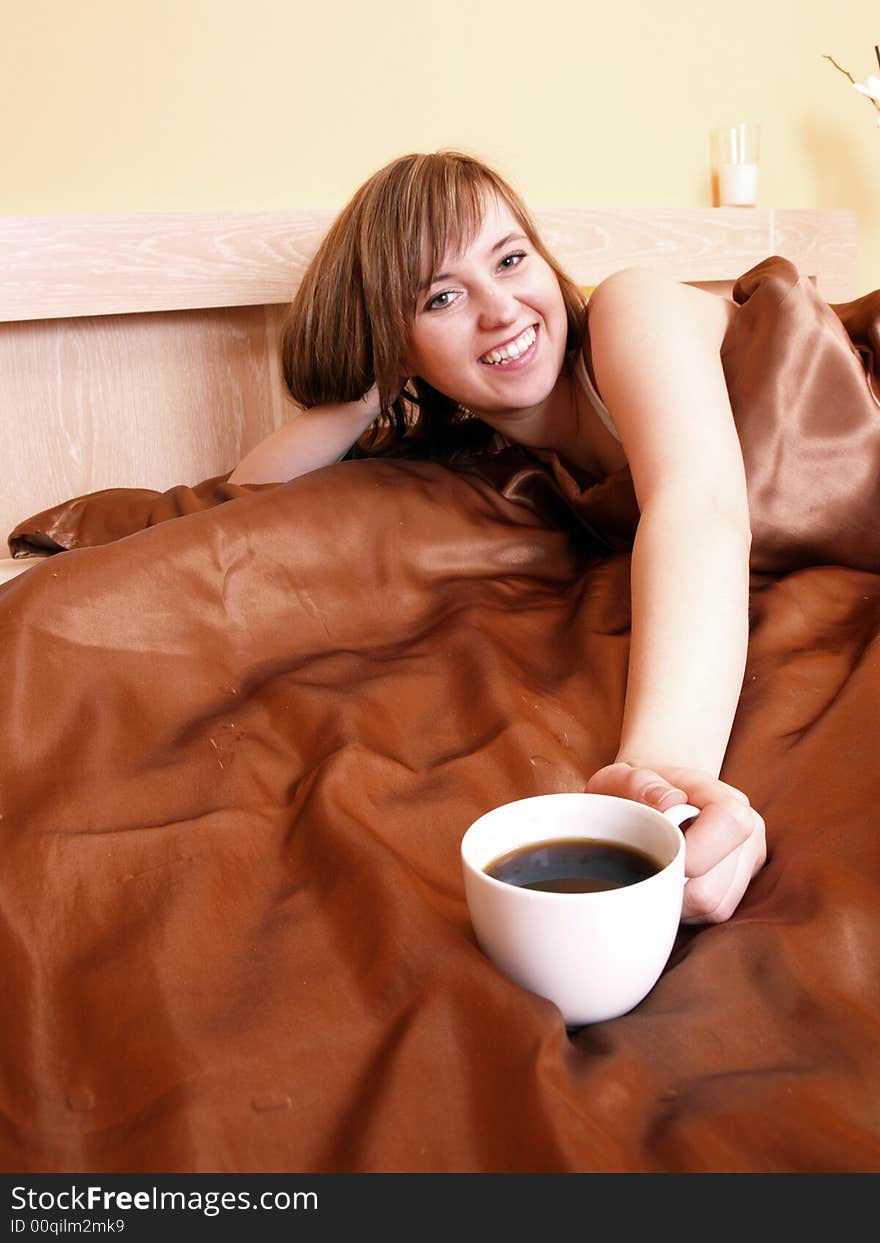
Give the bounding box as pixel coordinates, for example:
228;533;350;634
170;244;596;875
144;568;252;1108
0;208;856;321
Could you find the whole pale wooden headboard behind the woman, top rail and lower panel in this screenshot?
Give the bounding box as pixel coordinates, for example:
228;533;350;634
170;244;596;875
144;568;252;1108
0;208;864;579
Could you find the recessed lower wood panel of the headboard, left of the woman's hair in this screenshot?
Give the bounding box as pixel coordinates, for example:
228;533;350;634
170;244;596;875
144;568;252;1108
0;307;296;537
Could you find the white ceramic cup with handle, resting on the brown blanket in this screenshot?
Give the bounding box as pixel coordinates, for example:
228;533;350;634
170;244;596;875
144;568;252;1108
461;793;700;1027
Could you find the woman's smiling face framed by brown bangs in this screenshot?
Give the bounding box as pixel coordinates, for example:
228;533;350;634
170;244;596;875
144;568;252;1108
406;194;568;430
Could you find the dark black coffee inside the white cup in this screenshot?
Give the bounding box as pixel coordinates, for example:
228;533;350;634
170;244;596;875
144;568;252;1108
484;838;662;894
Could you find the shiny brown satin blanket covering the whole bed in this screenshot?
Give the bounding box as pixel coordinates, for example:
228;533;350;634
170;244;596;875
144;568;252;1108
0;259;880;1172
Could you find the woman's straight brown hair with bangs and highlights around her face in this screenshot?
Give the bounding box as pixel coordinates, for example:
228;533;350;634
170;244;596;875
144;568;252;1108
281;150;587;456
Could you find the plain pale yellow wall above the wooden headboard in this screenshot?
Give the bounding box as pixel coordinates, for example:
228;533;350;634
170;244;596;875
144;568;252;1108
0;0;880;290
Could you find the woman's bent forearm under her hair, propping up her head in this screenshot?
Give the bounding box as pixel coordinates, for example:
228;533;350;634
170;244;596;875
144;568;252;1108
229;388;379;484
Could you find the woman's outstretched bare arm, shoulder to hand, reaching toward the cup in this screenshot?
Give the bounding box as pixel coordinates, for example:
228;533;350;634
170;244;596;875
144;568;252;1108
590;270;763;919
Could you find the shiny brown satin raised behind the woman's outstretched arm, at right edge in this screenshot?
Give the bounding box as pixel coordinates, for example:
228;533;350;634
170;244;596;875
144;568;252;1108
721;255;880;572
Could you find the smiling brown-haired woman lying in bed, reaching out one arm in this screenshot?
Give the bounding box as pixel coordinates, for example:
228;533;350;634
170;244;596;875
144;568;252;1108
230;152;766;922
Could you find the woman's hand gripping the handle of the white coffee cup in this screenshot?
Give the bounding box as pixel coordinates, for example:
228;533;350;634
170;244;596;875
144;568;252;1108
587;761;767;924
